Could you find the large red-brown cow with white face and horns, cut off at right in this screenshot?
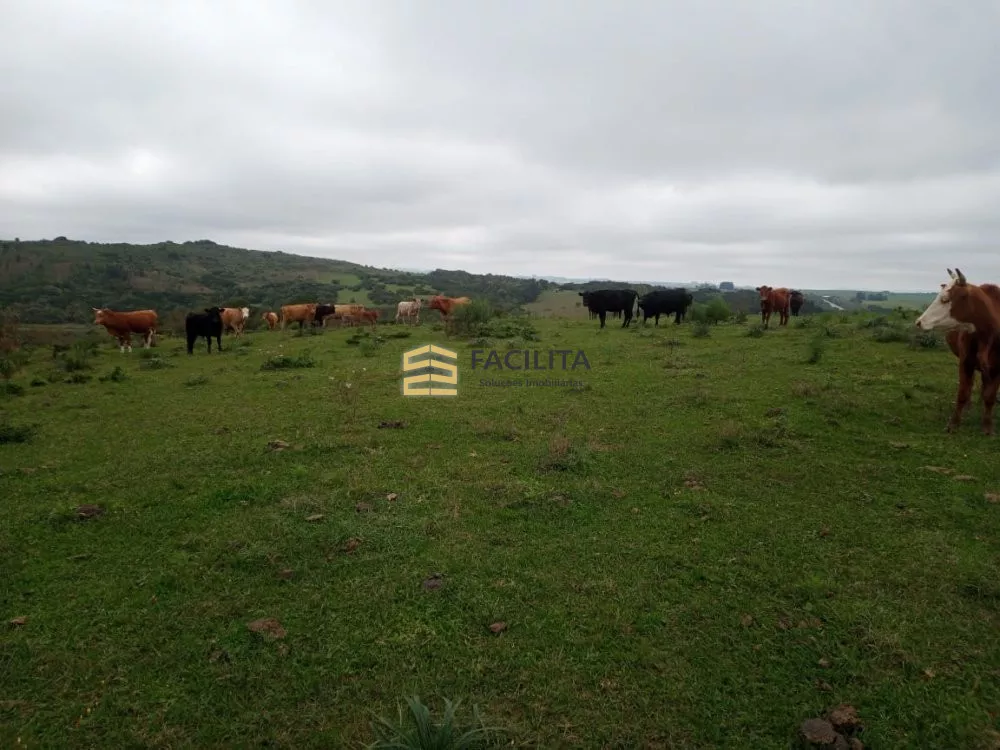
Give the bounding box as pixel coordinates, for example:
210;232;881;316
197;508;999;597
916;268;1000;435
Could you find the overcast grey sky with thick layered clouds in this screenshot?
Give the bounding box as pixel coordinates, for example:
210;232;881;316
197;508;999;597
0;0;1000;290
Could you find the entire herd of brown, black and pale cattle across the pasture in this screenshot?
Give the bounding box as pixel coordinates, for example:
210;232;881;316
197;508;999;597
93;268;1000;435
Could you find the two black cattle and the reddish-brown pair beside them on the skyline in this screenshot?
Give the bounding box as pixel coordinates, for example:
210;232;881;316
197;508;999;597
580;286;805;328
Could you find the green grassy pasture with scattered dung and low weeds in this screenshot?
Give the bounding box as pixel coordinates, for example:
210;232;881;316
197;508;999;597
0;315;1000;750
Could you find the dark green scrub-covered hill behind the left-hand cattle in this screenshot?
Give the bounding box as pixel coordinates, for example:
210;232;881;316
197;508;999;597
0;237;555;323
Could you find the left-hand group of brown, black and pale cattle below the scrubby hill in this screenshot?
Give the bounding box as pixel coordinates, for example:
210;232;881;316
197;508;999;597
92;294;470;354
